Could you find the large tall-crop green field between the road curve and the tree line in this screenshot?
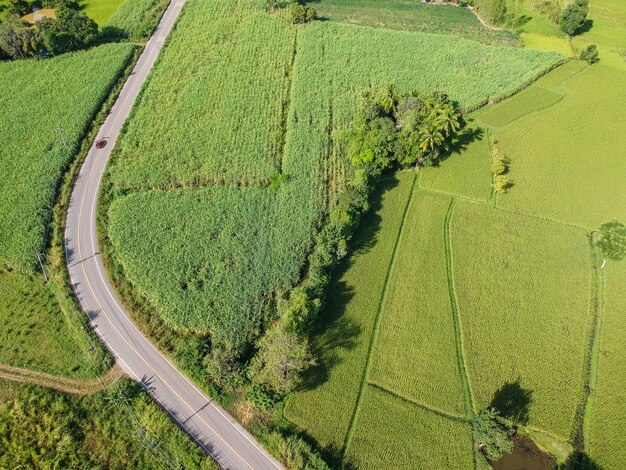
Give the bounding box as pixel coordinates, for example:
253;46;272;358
108;0;561;344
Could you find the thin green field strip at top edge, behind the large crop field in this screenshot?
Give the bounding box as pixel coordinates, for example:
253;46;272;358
304;0;519;46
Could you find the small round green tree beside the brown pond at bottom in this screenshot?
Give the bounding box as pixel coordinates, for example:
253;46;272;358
472;408;514;462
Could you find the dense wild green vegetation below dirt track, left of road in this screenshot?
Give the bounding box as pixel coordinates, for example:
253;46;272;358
0;381;216;469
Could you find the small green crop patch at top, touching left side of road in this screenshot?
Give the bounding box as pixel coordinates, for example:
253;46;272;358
102;0;170;40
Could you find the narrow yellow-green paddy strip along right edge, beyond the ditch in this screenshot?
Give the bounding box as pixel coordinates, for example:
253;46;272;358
587;261;626;469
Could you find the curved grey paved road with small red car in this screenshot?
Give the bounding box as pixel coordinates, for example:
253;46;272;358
64;0;281;470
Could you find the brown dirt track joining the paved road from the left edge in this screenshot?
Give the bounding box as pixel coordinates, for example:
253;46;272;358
0;364;124;396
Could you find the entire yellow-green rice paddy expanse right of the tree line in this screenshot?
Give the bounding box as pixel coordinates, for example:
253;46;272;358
285;49;626;469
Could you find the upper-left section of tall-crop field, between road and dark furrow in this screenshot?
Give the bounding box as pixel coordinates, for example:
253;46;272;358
111;1;295;188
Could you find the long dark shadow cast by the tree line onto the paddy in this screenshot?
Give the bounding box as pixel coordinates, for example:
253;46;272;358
298;175;398;390
